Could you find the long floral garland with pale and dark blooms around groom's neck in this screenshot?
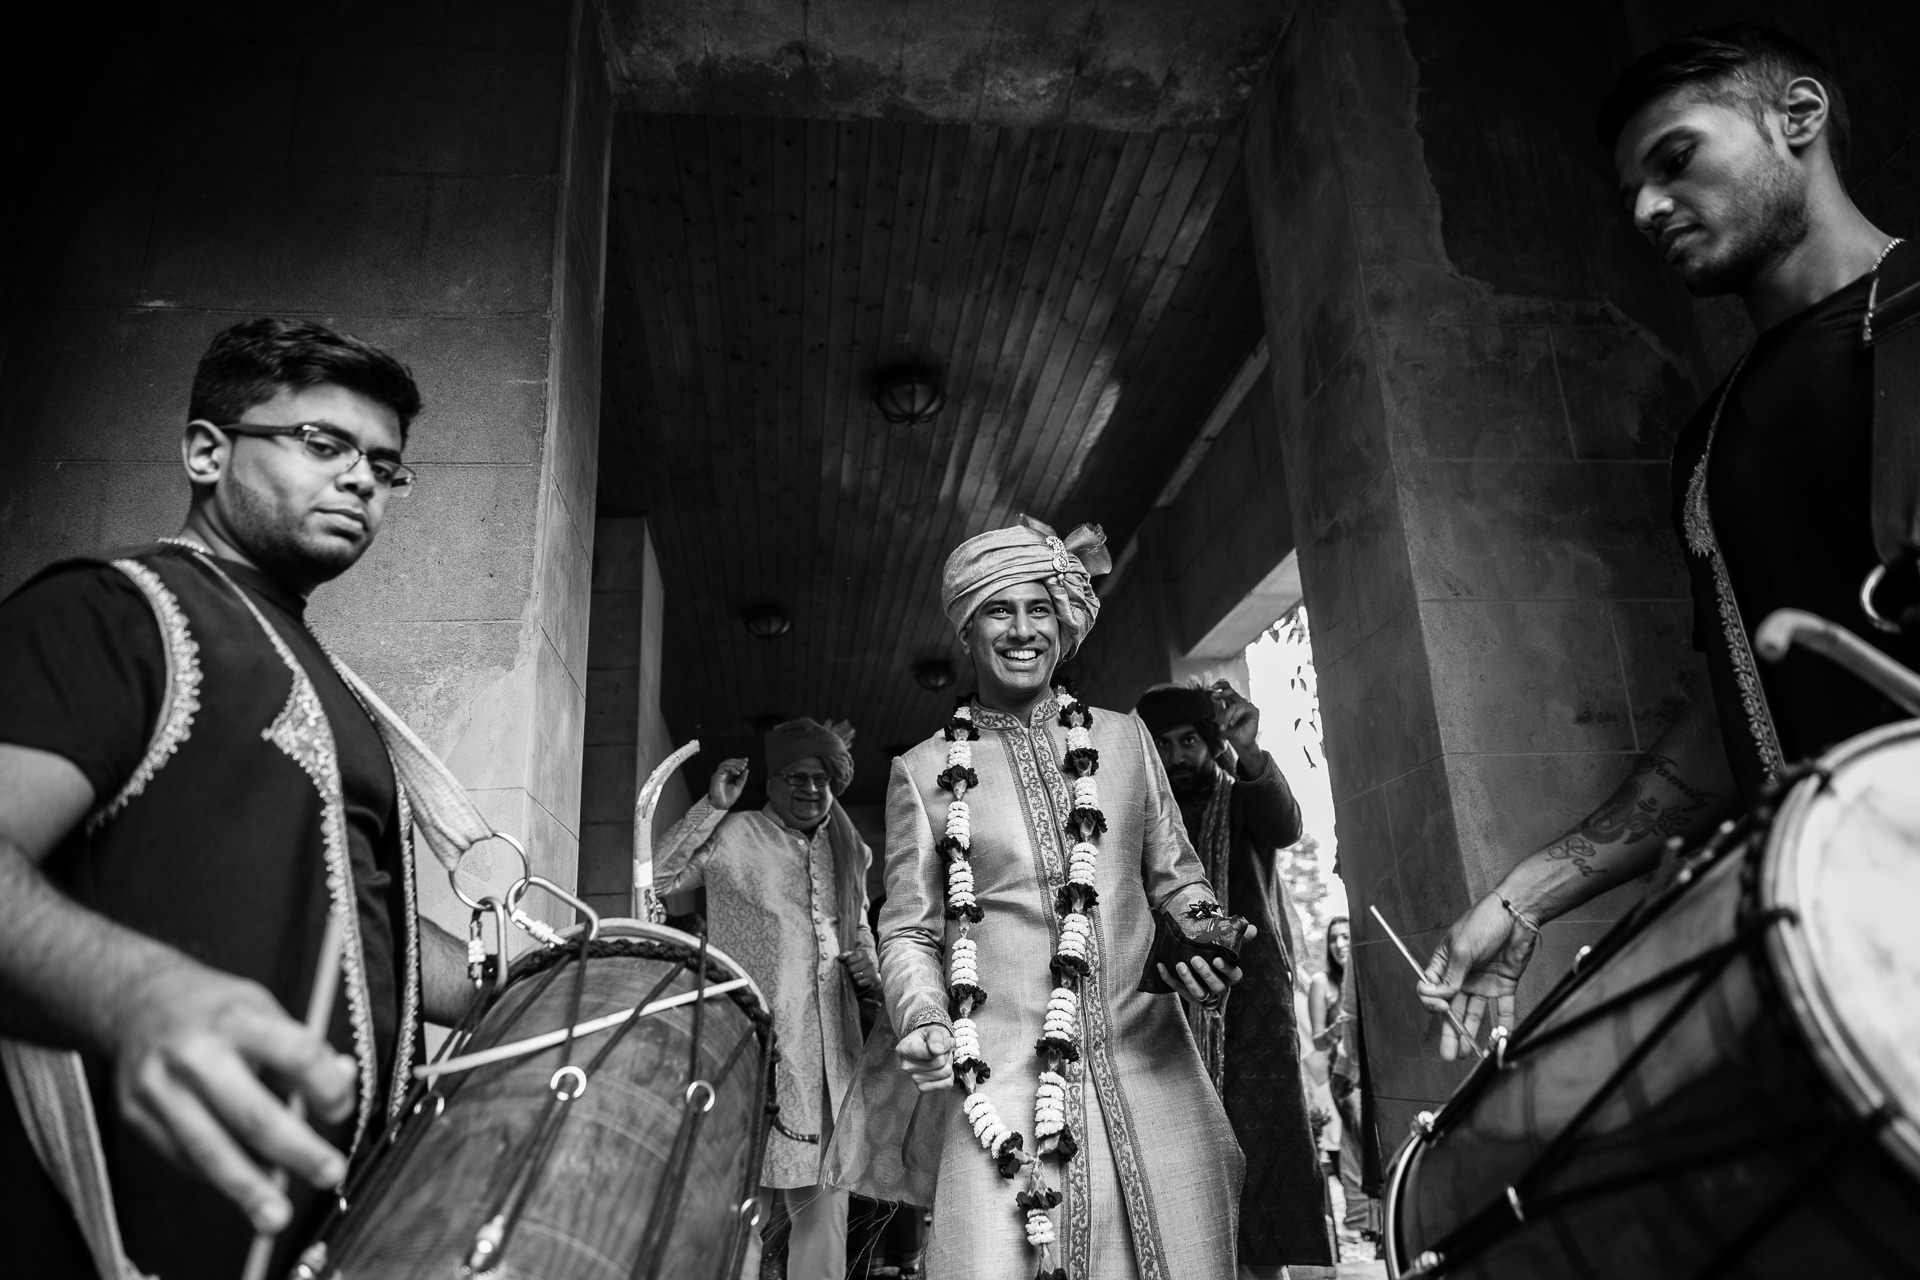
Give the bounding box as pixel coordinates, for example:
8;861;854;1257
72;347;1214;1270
935;689;1106;1280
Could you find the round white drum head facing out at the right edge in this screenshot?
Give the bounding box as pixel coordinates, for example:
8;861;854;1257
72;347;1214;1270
1763;722;1920;1174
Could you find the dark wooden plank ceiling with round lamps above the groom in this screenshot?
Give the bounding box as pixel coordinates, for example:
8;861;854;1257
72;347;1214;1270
599;115;1261;802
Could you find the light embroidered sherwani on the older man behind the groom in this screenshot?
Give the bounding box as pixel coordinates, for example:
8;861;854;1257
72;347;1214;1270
653;798;874;1188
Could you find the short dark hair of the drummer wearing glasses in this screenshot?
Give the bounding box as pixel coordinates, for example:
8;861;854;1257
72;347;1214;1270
186;317;420;443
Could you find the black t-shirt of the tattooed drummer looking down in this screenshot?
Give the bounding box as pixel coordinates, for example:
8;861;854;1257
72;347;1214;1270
1672;276;1920;793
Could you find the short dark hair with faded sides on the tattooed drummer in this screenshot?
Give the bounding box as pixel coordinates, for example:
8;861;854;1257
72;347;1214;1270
1594;23;1853;175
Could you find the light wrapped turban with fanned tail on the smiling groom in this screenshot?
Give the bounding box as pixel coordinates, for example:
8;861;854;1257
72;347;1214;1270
941;516;1114;660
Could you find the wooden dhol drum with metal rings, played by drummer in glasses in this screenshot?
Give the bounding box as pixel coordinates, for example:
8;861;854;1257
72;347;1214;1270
294;919;774;1280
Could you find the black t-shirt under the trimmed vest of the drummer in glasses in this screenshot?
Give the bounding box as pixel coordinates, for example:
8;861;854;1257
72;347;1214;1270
0;560;405;1084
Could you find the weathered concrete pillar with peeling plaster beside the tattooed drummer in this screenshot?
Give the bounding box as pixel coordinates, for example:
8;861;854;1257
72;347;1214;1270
1246;0;1707;1148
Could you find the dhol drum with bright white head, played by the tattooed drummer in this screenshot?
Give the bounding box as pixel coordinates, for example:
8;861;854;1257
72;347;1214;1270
1386;722;1920;1280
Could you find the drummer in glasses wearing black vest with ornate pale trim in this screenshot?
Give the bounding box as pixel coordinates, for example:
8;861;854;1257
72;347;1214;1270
0;320;470;1280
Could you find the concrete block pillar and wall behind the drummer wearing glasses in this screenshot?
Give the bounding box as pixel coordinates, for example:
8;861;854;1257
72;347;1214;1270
0;0;611;917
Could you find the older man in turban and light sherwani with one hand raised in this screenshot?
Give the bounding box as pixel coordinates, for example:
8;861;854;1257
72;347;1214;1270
653;720;877;1280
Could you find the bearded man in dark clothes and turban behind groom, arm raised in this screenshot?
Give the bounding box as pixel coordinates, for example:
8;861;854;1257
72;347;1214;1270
1133;679;1334;1280
